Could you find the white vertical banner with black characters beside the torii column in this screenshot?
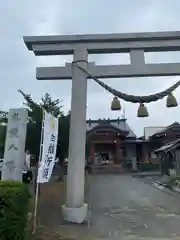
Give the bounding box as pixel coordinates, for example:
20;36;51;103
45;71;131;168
37;111;58;183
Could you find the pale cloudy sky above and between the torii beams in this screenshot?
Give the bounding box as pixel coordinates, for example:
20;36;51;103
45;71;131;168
0;0;180;136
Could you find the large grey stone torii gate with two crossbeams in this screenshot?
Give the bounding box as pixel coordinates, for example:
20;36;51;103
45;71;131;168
24;32;180;223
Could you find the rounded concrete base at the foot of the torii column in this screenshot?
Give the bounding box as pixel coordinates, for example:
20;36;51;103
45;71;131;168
62;203;88;224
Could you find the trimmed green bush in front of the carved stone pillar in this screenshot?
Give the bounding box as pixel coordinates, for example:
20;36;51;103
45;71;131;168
0;181;30;240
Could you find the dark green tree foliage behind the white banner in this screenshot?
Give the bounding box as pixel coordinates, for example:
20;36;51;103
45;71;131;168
0;89;70;163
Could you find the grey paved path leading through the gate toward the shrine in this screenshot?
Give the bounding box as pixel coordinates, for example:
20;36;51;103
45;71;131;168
88;175;180;240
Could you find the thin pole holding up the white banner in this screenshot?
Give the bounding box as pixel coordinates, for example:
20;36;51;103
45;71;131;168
32;109;45;235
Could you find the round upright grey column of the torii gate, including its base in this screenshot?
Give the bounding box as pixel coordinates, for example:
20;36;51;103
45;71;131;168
62;48;88;223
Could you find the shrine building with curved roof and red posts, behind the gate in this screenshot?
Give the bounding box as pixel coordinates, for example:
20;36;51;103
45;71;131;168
86;118;138;165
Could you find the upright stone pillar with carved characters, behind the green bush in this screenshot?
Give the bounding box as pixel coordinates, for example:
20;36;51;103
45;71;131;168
1;108;28;181
